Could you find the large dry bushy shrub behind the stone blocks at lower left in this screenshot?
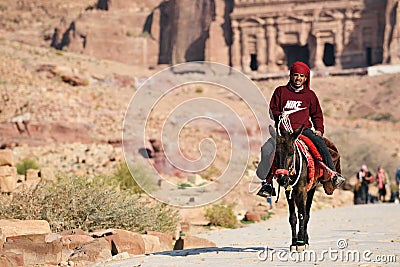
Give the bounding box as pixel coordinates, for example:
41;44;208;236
0;177;179;233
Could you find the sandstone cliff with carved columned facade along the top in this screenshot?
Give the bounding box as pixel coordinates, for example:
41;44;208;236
52;0;400;74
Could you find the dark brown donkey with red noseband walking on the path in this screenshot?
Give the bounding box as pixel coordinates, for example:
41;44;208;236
275;127;326;251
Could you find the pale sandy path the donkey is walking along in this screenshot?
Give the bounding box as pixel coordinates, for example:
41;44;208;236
94;204;400;267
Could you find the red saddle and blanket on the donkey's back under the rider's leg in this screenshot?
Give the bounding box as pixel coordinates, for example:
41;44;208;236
296;135;341;195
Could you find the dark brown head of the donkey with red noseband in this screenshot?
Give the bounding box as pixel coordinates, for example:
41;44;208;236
275;127;303;188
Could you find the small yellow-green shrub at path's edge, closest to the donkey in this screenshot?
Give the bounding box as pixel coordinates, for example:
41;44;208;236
205;204;237;228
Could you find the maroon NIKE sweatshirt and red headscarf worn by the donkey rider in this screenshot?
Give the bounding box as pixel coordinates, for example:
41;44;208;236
269;62;324;134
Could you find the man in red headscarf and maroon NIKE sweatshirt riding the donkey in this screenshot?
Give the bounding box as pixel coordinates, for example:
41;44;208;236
256;61;345;197
